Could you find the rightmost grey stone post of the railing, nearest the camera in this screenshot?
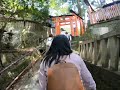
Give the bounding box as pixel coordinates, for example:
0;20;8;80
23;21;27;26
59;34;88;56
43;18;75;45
108;37;119;71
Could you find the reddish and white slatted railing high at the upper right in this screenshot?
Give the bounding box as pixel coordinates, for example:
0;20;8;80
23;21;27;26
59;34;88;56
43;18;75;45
89;3;120;24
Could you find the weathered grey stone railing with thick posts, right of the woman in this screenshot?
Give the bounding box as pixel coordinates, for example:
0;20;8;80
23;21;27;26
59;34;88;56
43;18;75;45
79;30;120;71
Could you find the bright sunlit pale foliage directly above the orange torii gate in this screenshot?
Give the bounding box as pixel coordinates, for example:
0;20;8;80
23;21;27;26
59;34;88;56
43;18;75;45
49;0;87;18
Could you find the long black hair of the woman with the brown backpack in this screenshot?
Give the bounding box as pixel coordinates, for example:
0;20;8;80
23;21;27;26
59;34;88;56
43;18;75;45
43;35;72;67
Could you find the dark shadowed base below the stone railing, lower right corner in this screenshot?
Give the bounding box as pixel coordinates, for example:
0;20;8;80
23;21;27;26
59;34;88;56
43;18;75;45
86;62;120;90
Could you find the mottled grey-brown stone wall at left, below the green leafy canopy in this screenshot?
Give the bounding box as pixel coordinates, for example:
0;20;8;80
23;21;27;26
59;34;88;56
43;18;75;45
0;21;47;47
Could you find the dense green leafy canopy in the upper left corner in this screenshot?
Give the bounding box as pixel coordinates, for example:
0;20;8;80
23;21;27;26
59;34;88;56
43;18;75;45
0;0;48;21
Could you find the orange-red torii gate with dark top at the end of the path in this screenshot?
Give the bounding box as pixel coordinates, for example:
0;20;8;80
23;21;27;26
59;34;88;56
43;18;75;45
52;13;85;36
